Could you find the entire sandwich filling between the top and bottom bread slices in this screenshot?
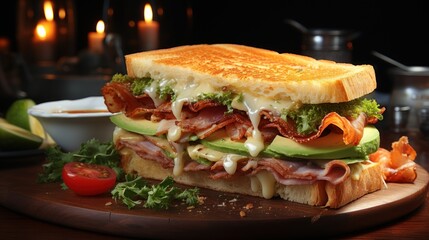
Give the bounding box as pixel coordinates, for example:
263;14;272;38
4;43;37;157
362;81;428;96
103;74;384;198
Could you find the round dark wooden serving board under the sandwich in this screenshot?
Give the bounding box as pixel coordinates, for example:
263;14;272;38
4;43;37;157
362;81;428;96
0;163;429;239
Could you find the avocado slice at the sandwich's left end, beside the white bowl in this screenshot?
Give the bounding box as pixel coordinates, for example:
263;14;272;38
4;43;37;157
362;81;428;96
110;114;158;136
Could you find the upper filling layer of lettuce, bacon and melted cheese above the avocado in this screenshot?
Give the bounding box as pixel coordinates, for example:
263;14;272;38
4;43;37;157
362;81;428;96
103;74;384;154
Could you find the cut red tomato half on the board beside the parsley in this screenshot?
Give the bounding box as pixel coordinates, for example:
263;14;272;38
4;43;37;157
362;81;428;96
62;162;116;196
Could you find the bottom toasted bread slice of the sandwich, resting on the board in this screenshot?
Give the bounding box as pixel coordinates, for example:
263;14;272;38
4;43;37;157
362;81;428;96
119;147;385;208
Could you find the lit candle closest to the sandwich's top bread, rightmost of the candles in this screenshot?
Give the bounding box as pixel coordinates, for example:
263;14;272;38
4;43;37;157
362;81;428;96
137;3;159;51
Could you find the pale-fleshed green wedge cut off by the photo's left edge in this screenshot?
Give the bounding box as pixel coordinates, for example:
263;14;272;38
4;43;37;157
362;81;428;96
0;120;43;151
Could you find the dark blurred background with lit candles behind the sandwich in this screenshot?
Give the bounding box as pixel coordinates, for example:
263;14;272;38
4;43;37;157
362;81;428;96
0;0;429;131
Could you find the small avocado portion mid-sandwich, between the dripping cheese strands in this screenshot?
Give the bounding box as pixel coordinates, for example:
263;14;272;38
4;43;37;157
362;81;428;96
201;130;280;156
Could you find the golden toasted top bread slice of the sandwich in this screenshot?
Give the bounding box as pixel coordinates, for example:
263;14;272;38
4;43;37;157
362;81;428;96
125;44;376;104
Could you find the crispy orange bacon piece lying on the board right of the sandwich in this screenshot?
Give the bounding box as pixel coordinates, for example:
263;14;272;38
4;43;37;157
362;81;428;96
369;136;417;183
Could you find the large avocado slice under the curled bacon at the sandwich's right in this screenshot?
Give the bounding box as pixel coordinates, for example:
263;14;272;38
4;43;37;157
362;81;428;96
266;126;380;159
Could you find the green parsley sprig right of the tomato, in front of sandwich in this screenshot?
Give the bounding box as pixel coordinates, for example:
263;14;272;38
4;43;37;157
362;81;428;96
111;175;199;209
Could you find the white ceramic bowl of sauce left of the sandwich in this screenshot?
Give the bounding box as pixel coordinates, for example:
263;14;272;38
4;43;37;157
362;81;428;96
28;97;115;151
